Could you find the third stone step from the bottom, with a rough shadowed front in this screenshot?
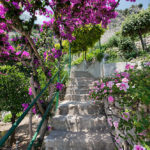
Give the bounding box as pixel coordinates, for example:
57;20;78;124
57;101;104;115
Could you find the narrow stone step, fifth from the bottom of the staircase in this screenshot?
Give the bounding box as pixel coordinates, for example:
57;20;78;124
66;88;90;94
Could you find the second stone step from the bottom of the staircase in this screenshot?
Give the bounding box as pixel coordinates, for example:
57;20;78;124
50;114;107;132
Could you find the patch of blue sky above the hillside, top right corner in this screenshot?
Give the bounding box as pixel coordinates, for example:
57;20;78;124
118;0;150;9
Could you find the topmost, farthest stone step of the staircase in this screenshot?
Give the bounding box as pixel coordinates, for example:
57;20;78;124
70;71;92;78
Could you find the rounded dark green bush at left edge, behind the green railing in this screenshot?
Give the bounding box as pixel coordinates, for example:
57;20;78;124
0;66;30;114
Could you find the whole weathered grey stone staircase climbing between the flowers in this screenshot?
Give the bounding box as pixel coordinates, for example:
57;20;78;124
45;71;115;150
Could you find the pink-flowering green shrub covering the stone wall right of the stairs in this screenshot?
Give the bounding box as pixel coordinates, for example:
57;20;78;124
89;62;150;150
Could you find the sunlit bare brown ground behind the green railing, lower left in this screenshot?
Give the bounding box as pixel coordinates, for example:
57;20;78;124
0;116;40;150
